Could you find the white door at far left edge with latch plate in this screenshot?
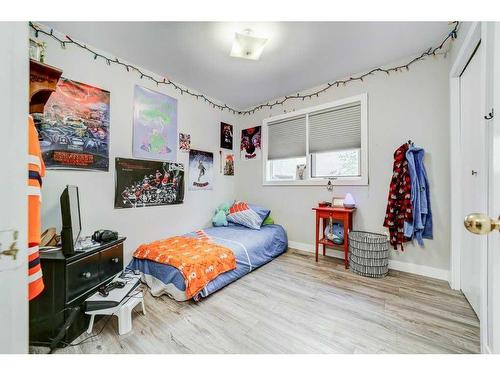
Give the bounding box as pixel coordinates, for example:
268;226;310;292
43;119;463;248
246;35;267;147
0;22;29;354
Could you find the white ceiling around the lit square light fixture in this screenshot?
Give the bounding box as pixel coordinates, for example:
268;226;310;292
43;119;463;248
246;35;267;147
41;22;449;109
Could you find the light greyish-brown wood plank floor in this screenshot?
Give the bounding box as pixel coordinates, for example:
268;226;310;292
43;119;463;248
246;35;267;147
41;250;479;353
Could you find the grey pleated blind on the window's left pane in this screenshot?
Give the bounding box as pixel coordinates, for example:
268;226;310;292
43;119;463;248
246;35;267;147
267;115;306;160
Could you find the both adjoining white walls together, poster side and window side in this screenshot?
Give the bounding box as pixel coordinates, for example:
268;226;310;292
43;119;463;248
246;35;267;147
35;24;456;273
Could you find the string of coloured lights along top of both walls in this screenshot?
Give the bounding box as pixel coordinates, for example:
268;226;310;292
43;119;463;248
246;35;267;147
29;21;460;115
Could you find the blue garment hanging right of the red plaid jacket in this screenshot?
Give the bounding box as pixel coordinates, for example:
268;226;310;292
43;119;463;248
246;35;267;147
404;146;432;246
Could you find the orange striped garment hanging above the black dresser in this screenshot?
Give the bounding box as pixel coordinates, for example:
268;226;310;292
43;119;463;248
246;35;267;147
28;116;45;301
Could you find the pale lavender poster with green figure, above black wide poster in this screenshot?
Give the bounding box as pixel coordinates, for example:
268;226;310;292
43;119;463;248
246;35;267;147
132;85;177;161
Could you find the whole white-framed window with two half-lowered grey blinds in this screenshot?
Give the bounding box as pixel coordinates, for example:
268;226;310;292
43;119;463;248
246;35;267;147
263;94;368;185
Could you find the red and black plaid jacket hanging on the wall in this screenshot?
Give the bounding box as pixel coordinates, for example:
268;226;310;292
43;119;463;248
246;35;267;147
384;143;413;250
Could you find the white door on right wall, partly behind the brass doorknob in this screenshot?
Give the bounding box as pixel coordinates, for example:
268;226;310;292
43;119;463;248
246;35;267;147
460;45;488;317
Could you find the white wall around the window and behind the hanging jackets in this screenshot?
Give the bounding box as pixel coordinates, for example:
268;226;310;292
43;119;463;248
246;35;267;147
235;58;450;277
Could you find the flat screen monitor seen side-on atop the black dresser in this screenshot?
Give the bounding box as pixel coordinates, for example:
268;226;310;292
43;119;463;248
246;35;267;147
61;185;82;255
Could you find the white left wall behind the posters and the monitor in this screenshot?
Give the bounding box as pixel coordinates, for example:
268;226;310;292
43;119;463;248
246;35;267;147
35;28;235;262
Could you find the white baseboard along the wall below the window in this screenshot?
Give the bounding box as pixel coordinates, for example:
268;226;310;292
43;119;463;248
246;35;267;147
288;241;450;281
